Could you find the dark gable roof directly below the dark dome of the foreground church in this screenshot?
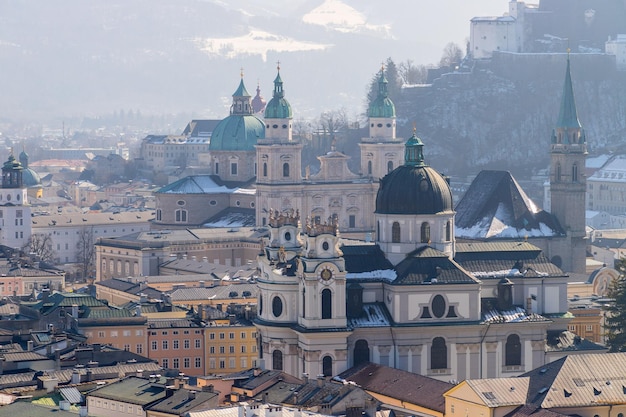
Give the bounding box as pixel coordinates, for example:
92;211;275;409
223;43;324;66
393;246;478;285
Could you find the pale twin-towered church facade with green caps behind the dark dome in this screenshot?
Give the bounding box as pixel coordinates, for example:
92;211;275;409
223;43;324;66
256;69;403;238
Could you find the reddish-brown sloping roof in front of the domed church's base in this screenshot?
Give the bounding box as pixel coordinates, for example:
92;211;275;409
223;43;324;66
338;363;454;413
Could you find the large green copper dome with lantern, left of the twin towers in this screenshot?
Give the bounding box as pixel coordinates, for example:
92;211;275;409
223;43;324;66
209;78;265;151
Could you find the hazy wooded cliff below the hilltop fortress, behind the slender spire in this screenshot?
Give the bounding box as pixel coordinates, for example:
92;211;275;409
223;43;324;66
395;54;626;178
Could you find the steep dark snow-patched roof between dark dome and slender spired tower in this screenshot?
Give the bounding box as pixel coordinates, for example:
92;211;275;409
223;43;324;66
455;171;565;239
